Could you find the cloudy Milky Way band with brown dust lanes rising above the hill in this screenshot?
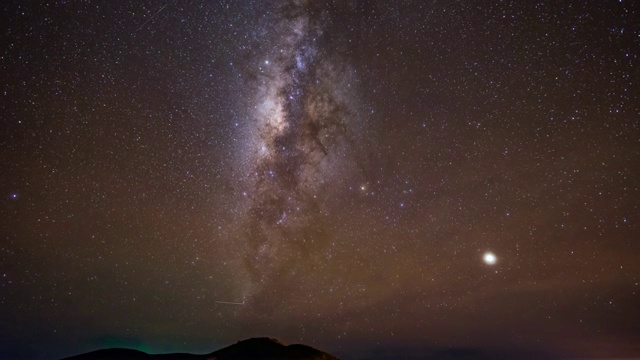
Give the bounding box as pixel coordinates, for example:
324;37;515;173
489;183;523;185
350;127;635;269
232;2;359;296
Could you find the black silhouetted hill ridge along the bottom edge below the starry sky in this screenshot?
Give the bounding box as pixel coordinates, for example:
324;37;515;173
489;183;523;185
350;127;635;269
63;338;338;360
